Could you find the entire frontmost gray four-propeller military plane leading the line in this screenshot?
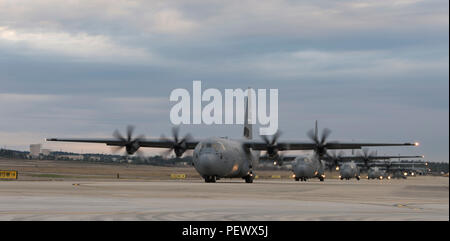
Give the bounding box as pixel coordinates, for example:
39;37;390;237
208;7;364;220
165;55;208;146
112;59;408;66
47;98;417;183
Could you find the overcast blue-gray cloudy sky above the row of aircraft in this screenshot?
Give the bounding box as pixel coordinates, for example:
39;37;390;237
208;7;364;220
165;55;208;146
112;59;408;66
0;0;449;161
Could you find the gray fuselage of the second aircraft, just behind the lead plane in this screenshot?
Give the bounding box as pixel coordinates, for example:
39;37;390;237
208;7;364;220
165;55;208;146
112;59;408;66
292;155;325;181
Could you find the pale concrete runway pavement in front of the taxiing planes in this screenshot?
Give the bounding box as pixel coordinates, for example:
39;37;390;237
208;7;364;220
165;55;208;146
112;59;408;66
0;177;449;221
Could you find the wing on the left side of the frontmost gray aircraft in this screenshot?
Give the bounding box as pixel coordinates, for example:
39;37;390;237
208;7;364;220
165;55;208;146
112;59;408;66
47;138;198;149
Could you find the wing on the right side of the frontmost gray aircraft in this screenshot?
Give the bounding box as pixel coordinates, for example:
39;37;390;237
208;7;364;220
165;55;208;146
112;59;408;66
245;141;419;151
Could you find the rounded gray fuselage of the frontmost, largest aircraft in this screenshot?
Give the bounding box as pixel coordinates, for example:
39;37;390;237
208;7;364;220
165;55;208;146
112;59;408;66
193;138;256;178
